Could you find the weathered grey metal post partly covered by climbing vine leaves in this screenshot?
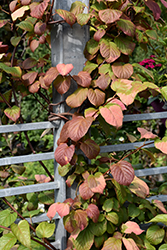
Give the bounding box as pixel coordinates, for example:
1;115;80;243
51;0;89;250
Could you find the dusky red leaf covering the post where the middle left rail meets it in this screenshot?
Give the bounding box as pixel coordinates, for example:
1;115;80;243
54;143;75;166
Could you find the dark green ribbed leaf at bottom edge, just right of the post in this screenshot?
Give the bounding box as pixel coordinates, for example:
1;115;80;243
73;227;94;250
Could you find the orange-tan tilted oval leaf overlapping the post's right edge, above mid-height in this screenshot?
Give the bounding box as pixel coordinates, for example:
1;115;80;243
66;87;88;108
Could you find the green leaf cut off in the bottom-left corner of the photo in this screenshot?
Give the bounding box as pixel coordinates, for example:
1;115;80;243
0;233;17;250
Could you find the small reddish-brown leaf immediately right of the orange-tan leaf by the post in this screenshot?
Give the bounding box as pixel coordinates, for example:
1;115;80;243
88;88;105;107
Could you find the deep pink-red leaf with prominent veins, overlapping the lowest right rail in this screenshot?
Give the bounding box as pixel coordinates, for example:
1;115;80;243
110;161;135;186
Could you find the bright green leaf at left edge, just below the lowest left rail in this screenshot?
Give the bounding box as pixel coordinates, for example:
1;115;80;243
0;209;17;232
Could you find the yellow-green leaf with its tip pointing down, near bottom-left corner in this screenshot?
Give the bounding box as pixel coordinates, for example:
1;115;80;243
10;220;31;248
